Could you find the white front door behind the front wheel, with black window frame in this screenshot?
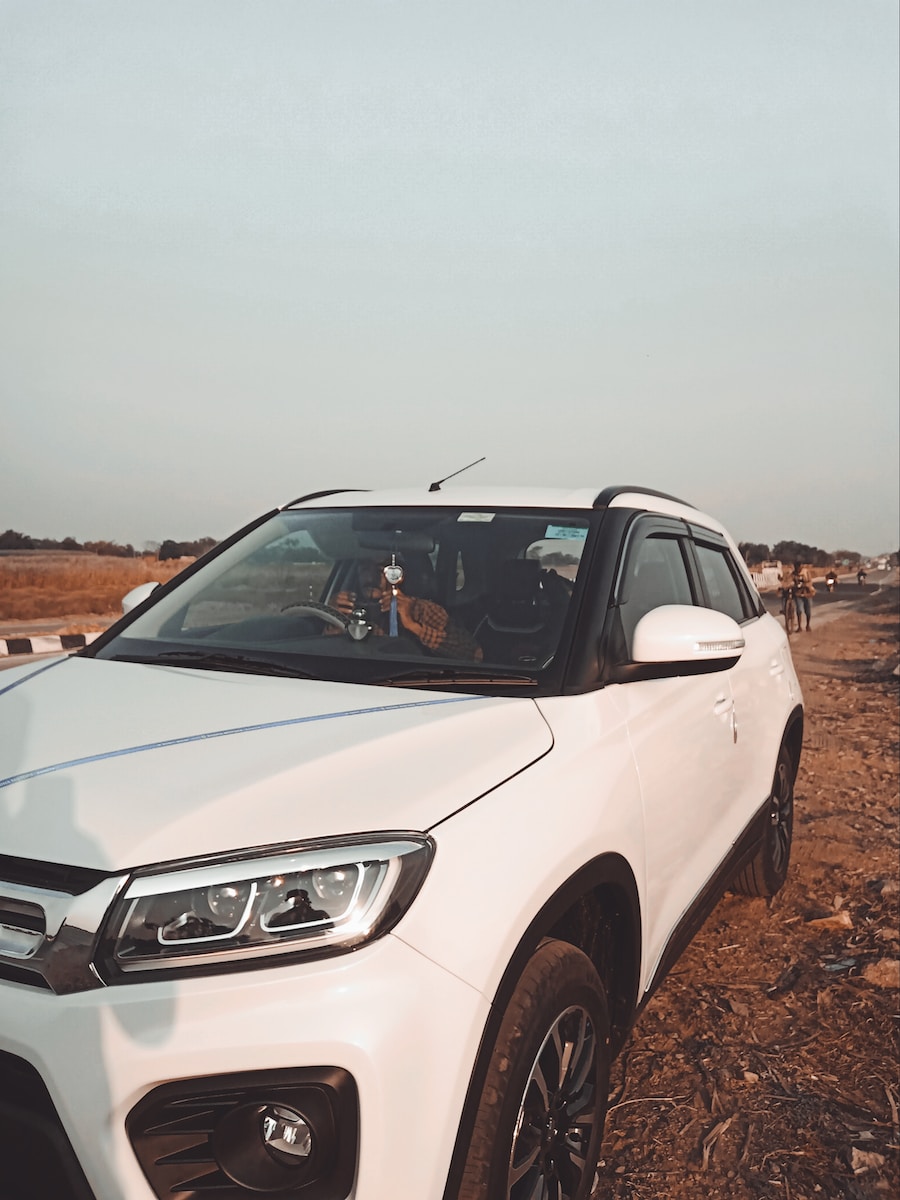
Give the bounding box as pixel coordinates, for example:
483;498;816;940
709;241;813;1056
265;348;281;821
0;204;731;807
611;518;737;974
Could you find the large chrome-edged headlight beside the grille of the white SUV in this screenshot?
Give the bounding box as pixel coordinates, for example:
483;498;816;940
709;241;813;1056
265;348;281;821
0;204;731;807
101;834;433;983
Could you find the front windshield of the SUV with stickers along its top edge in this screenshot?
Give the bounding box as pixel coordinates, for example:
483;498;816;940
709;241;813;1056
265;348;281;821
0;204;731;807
95;508;589;685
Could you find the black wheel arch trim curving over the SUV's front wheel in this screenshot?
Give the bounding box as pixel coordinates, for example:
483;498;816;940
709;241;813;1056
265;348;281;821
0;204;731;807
444;854;641;1200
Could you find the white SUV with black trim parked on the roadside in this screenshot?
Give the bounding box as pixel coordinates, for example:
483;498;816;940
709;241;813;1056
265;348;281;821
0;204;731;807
0;487;803;1200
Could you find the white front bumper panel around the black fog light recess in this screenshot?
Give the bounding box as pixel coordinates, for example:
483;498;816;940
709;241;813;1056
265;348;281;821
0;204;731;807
0;935;488;1200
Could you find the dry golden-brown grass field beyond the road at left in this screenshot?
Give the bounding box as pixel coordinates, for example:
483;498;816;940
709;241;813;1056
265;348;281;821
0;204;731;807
0;550;186;631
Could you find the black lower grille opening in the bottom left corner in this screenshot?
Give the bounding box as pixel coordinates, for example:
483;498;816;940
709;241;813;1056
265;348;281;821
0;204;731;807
0;1050;96;1200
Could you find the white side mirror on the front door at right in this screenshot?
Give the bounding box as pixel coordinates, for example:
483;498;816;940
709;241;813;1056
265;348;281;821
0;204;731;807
614;604;745;683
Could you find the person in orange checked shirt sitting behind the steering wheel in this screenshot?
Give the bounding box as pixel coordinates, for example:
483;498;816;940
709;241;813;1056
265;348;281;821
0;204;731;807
334;559;482;662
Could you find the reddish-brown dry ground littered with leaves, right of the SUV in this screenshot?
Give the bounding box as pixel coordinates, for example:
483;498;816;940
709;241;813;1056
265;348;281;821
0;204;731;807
596;587;900;1200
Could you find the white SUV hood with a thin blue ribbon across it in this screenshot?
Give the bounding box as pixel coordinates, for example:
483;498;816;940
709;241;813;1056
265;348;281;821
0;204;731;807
0;658;552;870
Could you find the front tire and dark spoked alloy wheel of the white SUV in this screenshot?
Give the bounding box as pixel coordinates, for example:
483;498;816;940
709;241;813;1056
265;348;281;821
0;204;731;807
457;941;610;1200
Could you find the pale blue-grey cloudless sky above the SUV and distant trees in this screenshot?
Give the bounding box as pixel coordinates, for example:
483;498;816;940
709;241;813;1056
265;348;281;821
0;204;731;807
0;0;900;553
